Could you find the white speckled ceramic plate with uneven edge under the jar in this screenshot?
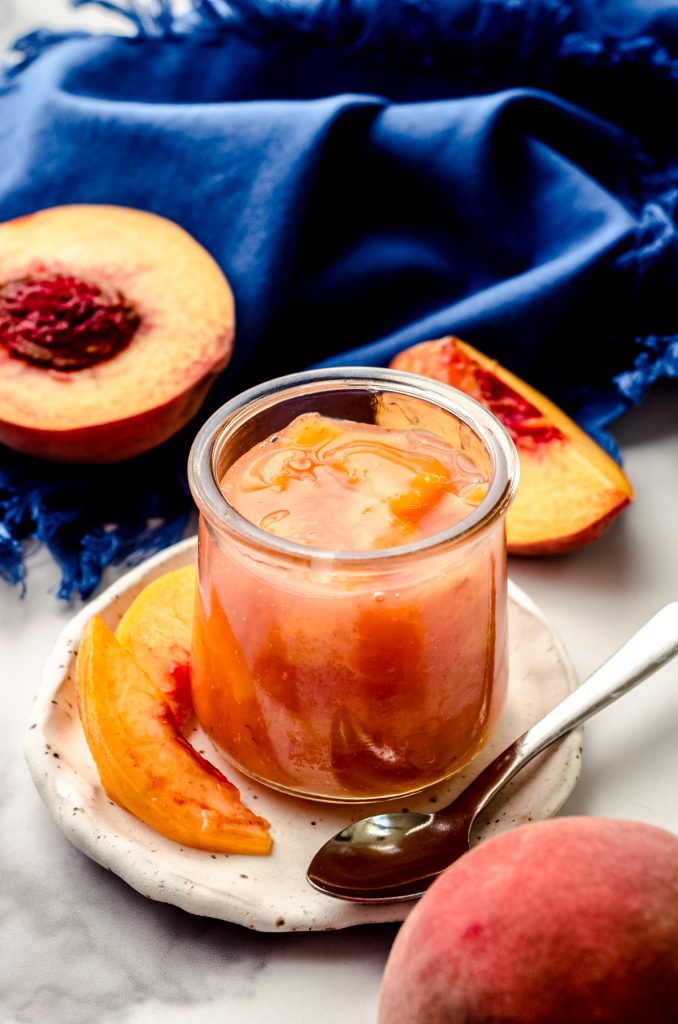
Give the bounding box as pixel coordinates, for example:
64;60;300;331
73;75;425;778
26;538;582;932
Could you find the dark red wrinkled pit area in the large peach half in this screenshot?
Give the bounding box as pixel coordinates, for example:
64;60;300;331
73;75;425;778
0;273;140;371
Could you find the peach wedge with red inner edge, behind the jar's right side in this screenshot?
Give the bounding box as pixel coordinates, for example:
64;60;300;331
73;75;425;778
391;337;633;555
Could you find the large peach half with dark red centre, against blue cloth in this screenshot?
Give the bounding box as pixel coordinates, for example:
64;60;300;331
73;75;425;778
0;205;234;463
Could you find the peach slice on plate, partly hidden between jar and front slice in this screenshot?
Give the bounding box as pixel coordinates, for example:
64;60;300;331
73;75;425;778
116;565;196;728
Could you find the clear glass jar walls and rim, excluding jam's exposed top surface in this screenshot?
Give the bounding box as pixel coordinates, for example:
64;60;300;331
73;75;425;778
189;368;517;802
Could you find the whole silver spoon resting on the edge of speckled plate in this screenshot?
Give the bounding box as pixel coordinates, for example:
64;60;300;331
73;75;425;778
307;601;678;903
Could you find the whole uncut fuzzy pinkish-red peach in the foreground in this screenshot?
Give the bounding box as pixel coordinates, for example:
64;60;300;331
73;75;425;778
379;817;678;1024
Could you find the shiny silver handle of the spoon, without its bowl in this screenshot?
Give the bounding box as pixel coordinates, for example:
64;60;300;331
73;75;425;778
448;601;678;816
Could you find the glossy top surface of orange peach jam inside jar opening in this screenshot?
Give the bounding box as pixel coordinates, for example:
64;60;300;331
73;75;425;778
221;413;488;551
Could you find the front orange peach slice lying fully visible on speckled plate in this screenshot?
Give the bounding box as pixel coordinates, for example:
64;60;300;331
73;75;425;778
77;615;271;854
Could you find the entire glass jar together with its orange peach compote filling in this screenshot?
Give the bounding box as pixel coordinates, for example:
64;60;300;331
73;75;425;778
190;369;516;801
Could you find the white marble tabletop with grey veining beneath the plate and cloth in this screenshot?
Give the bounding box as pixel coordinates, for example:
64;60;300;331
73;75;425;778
0;0;678;1024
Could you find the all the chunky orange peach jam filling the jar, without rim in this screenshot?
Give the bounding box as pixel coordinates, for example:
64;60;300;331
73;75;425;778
193;413;507;800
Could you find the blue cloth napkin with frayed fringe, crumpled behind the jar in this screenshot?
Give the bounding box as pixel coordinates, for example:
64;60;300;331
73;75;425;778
0;0;678;597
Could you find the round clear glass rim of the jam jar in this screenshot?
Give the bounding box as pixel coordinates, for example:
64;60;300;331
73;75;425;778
188;367;519;567
